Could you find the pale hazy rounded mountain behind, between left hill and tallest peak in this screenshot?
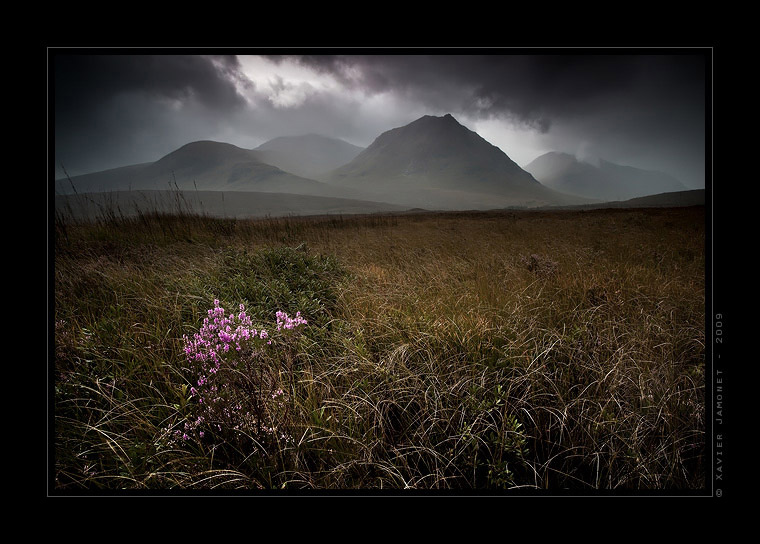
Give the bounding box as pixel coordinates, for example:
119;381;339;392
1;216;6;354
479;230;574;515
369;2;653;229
254;134;364;179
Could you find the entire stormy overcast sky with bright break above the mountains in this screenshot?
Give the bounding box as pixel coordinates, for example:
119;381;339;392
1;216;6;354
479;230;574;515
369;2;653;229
49;49;710;188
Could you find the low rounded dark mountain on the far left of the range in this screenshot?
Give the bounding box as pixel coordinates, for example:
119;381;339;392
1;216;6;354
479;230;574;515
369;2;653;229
56;141;354;197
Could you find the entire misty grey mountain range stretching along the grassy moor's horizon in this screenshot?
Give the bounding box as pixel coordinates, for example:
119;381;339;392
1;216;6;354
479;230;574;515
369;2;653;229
55;115;700;215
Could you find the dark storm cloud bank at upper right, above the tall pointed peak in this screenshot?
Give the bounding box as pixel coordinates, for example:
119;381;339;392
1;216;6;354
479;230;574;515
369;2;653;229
288;54;704;131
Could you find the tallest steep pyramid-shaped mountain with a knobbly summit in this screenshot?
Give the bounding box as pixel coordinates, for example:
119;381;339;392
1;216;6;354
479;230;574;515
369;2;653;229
319;114;580;209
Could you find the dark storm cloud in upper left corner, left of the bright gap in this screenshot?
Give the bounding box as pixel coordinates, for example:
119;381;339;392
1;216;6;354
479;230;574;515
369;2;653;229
51;53;245;172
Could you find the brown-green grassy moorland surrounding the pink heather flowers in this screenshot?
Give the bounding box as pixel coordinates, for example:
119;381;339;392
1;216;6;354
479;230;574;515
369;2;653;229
49;207;707;493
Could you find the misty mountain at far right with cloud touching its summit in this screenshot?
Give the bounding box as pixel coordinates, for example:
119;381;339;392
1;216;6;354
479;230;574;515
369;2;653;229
525;151;688;201
